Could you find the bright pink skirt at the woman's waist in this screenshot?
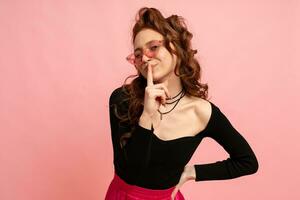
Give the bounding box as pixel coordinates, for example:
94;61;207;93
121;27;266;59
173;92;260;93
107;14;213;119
105;173;185;200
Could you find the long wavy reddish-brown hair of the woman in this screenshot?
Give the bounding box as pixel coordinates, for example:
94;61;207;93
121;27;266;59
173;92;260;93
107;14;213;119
114;7;208;148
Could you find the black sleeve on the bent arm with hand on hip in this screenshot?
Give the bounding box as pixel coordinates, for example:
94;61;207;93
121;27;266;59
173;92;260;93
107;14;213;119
195;106;258;181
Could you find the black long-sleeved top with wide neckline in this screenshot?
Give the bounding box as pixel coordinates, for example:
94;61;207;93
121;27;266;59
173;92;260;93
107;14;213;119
109;87;258;189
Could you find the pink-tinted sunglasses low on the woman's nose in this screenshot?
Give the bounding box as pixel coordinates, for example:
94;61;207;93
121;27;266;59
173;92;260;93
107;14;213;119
126;40;164;66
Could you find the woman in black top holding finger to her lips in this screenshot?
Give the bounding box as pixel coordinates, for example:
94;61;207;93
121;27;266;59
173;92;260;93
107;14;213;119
105;7;258;200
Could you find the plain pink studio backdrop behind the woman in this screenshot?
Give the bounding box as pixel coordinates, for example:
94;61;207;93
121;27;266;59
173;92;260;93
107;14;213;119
0;0;300;200
